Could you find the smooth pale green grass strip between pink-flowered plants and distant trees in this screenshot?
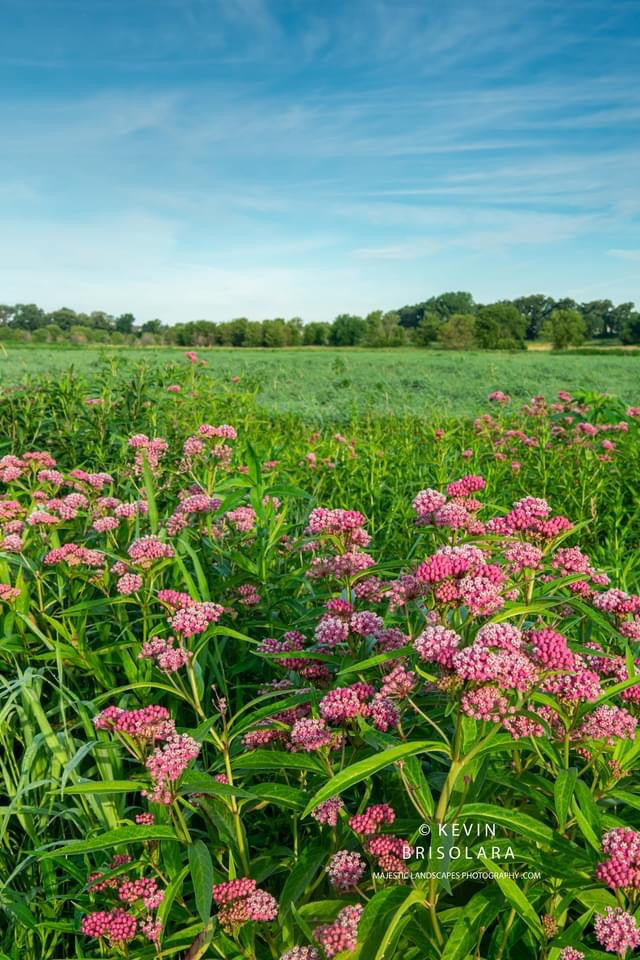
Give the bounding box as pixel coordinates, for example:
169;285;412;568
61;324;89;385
0;346;640;421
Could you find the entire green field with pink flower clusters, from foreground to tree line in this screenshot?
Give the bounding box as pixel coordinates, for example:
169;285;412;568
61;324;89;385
0;349;640;960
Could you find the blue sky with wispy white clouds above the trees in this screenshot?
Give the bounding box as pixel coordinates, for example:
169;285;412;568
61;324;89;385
0;0;640;322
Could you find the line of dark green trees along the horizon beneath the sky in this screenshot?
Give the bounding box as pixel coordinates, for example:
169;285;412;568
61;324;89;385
0;291;640;350
